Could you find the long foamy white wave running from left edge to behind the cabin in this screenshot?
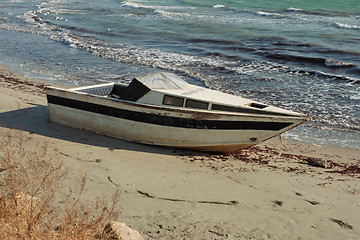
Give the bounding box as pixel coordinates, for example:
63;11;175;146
0;12;230;82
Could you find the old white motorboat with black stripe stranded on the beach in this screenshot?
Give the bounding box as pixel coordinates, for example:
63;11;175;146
46;72;307;153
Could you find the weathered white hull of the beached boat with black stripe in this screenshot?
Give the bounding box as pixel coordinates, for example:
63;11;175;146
47;89;306;152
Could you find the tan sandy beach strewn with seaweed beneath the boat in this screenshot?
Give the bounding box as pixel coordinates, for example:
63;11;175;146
0;66;360;239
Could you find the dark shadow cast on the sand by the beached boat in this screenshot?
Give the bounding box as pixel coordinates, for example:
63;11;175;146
0;103;197;156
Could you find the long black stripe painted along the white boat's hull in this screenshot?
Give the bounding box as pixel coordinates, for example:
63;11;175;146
47;95;292;131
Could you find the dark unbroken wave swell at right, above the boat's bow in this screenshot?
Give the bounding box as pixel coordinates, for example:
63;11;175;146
188;38;360;79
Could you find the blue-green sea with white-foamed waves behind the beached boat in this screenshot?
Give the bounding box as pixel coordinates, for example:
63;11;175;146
0;0;360;149
